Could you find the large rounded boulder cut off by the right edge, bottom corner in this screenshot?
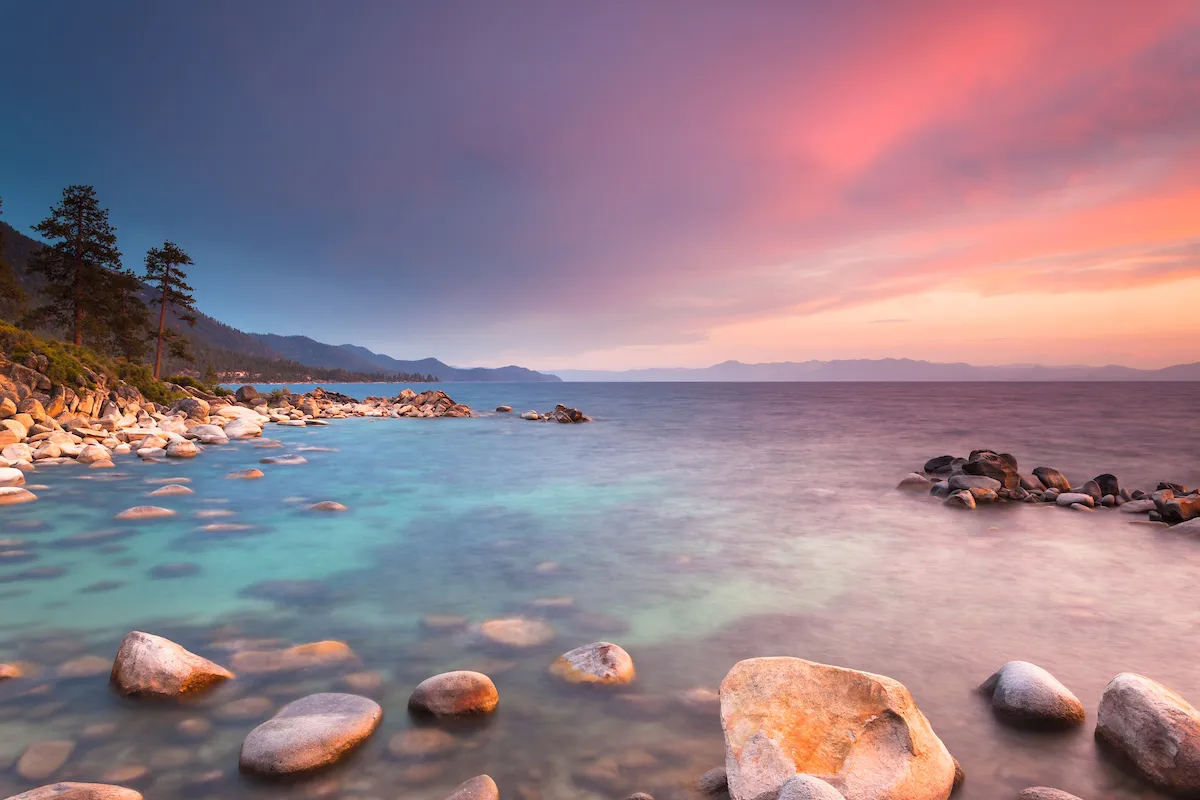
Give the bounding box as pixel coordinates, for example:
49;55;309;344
1096;672;1200;798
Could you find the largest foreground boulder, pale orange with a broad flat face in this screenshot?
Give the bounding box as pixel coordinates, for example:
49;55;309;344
721;657;954;800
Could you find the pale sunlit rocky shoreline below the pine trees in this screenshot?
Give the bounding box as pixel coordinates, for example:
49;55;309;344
0;356;592;505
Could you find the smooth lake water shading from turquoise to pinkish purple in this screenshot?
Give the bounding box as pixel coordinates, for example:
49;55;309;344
0;384;1200;800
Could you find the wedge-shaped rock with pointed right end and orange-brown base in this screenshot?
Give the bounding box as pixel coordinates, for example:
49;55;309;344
112;631;233;697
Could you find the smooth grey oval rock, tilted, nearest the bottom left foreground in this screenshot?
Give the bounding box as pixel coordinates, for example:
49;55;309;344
239;692;383;775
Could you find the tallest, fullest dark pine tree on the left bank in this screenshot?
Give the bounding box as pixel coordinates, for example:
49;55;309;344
29;186;121;344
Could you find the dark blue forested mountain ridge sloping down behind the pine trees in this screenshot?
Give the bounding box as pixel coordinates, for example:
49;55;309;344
0;222;559;383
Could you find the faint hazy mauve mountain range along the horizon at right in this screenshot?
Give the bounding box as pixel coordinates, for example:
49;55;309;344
556;359;1200;383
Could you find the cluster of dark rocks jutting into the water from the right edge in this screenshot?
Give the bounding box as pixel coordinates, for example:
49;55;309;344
896;450;1200;533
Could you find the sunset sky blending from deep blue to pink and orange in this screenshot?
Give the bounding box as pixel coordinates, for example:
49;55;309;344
0;0;1200;369
